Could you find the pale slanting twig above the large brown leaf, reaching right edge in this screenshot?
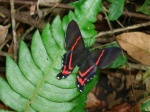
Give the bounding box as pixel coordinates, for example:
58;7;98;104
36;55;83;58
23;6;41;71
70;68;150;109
95;22;150;38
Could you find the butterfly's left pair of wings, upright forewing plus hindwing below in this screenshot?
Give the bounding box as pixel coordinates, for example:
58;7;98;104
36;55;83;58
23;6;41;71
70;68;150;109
56;20;85;79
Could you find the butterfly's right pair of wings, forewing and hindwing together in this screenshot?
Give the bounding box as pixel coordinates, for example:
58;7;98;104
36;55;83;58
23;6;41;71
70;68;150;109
77;47;122;92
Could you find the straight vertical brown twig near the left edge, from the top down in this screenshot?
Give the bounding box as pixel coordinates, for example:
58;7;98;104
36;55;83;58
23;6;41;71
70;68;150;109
10;0;18;62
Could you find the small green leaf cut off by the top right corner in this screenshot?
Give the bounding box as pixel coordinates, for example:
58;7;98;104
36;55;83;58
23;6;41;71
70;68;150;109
137;0;150;16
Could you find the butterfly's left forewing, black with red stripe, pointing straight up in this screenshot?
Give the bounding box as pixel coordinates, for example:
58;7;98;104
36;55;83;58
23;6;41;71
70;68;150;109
65;20;85;52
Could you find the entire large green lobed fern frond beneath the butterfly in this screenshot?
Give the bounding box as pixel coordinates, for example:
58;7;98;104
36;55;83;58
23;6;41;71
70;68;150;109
0;0;101;112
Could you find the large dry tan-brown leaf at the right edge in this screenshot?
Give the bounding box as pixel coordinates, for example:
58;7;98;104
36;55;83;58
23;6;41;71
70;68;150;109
116;32;150;65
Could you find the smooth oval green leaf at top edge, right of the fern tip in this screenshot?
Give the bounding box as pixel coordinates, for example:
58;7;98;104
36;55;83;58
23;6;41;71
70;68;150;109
108;0;124;21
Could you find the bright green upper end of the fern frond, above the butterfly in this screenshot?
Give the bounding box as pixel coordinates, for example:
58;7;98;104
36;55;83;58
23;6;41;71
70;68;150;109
63;0;101;47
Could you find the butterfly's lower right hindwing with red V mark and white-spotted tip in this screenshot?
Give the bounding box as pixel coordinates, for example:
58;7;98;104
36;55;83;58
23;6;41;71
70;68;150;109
77;56;97;92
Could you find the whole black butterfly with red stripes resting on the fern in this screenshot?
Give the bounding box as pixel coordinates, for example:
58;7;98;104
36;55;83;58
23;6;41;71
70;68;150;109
56;20;122;92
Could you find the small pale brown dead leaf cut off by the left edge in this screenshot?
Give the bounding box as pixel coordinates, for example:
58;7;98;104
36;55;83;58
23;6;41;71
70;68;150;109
0;25;8;44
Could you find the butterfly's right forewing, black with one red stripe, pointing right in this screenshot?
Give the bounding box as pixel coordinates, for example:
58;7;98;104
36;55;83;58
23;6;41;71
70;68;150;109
91;47;122;69
